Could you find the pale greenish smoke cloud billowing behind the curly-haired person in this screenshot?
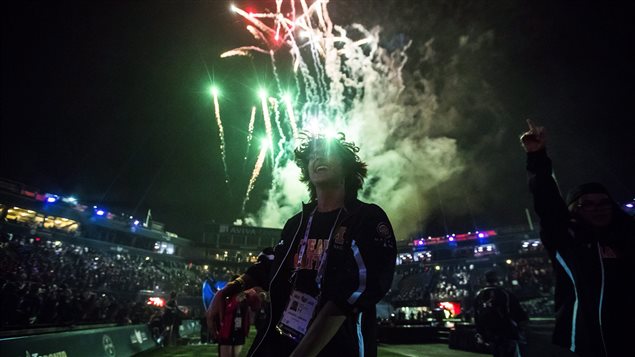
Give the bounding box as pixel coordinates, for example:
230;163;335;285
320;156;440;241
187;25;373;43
234;2;472;239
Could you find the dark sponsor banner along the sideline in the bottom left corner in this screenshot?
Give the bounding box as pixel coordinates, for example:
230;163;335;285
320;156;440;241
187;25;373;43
0;325;157;357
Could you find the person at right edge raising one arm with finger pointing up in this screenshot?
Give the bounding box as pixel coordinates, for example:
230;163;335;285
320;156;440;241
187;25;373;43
520;120;635;356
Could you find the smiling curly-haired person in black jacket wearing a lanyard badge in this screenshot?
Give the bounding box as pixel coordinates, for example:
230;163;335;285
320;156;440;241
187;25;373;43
207;134;397;357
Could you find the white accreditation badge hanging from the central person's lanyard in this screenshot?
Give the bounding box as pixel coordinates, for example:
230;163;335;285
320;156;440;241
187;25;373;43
276;290;318;341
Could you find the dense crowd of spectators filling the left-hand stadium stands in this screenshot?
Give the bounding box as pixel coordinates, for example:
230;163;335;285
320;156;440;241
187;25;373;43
0;233;233;330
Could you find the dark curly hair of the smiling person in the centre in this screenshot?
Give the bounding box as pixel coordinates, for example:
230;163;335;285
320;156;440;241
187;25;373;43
294;131;368;201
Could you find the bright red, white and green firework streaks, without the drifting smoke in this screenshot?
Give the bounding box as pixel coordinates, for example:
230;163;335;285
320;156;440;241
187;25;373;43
214;0;400;221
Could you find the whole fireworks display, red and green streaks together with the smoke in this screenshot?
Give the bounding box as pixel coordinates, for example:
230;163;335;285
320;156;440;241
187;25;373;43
211;0;461;236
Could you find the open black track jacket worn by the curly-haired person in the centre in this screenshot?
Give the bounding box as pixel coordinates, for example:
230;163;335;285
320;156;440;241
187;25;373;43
247;199;397;357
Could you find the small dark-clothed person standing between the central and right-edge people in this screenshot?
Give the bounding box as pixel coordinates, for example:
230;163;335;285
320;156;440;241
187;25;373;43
474;270;529;357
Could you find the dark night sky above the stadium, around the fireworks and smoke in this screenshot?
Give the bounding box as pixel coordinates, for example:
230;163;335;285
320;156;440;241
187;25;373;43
0;0;635;239
